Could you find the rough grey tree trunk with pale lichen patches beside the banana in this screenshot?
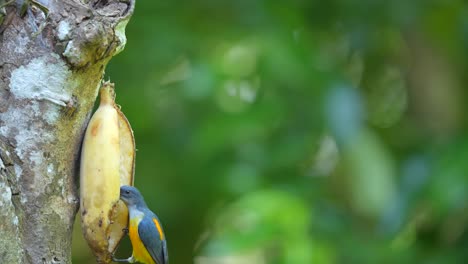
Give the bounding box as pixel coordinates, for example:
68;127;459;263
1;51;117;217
0;0;134;263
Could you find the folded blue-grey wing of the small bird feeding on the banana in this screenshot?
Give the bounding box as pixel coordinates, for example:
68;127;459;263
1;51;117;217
138;215;169;264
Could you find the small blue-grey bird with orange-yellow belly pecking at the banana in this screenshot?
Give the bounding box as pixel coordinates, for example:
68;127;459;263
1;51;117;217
113;186;169;264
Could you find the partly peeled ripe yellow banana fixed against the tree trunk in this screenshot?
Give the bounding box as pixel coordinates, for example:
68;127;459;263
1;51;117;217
80;82;135;263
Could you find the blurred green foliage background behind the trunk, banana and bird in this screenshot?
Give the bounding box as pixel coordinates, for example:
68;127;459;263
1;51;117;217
73;0;468;264
